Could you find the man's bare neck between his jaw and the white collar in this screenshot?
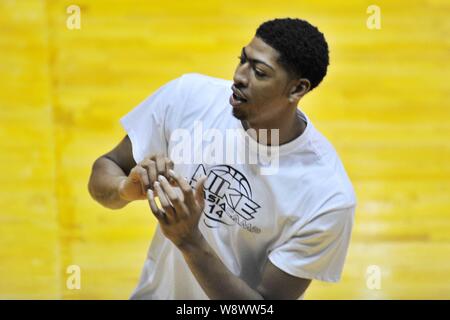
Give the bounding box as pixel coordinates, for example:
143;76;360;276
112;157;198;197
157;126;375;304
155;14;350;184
241;108;306;146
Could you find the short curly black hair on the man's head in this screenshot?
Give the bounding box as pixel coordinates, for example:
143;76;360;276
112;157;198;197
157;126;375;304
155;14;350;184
256;18;329;90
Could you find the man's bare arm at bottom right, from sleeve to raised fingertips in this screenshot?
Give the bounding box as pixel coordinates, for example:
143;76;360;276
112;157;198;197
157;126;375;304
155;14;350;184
148;171;311;299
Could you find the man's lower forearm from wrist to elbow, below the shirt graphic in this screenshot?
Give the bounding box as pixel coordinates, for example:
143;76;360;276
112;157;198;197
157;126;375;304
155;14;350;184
180;237;264;300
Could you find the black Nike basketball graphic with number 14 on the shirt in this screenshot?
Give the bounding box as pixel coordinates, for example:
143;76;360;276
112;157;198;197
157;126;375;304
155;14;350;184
190;165;261;233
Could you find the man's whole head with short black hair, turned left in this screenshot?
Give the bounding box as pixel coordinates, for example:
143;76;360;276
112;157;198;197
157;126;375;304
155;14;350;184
230;18;329;124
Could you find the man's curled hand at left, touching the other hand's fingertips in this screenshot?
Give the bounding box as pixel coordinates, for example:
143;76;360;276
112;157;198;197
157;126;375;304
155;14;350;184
119;155;173;201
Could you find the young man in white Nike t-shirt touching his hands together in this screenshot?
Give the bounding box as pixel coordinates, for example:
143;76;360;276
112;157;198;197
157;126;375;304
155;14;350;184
89;19;356;299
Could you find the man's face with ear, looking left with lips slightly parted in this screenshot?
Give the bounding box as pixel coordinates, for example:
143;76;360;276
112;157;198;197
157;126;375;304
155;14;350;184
230;37;297;125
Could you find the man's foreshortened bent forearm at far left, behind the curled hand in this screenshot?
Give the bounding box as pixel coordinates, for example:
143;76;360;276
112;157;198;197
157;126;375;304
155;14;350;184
88;157;129;209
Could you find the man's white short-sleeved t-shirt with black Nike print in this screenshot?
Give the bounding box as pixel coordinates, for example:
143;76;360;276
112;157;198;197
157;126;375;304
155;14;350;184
120;74;356;299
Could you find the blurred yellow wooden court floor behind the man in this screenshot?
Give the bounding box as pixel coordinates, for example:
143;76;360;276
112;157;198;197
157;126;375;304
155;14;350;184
0;0;450;299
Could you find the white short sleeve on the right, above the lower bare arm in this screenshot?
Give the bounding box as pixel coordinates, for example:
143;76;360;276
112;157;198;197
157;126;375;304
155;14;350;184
269;207;354;282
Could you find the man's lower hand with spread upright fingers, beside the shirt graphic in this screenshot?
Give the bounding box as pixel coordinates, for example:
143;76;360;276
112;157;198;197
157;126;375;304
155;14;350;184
147;170;207;249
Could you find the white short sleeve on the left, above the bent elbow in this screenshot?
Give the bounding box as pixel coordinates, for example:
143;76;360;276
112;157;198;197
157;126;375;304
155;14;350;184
120;77;185;163
